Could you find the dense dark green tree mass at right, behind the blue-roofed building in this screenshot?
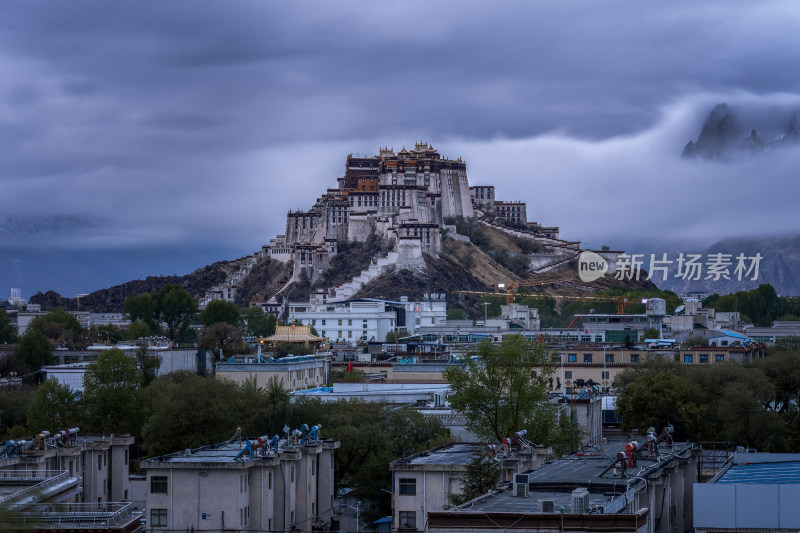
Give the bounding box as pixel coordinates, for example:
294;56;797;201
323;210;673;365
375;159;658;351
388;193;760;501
614;354;800;451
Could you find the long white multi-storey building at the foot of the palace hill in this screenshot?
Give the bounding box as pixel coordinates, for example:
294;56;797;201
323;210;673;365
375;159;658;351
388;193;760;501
289;297;447;344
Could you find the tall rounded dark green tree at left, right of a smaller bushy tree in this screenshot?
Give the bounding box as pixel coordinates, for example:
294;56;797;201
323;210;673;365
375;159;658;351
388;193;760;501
83;348;145;433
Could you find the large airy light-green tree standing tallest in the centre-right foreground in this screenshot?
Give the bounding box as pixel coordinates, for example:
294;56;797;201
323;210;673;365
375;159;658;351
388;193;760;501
444;335;553;441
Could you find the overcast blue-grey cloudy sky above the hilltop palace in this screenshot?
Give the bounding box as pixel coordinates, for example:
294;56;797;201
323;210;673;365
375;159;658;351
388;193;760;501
0;0;800;258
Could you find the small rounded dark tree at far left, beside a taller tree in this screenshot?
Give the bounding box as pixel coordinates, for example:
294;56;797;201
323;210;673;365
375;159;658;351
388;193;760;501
28;379;80;433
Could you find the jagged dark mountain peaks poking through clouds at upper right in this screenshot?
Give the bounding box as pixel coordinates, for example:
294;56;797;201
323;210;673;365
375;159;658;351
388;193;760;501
681;104;800;159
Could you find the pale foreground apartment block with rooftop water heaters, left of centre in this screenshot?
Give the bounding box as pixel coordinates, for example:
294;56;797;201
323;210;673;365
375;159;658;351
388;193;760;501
141;430;339;532
